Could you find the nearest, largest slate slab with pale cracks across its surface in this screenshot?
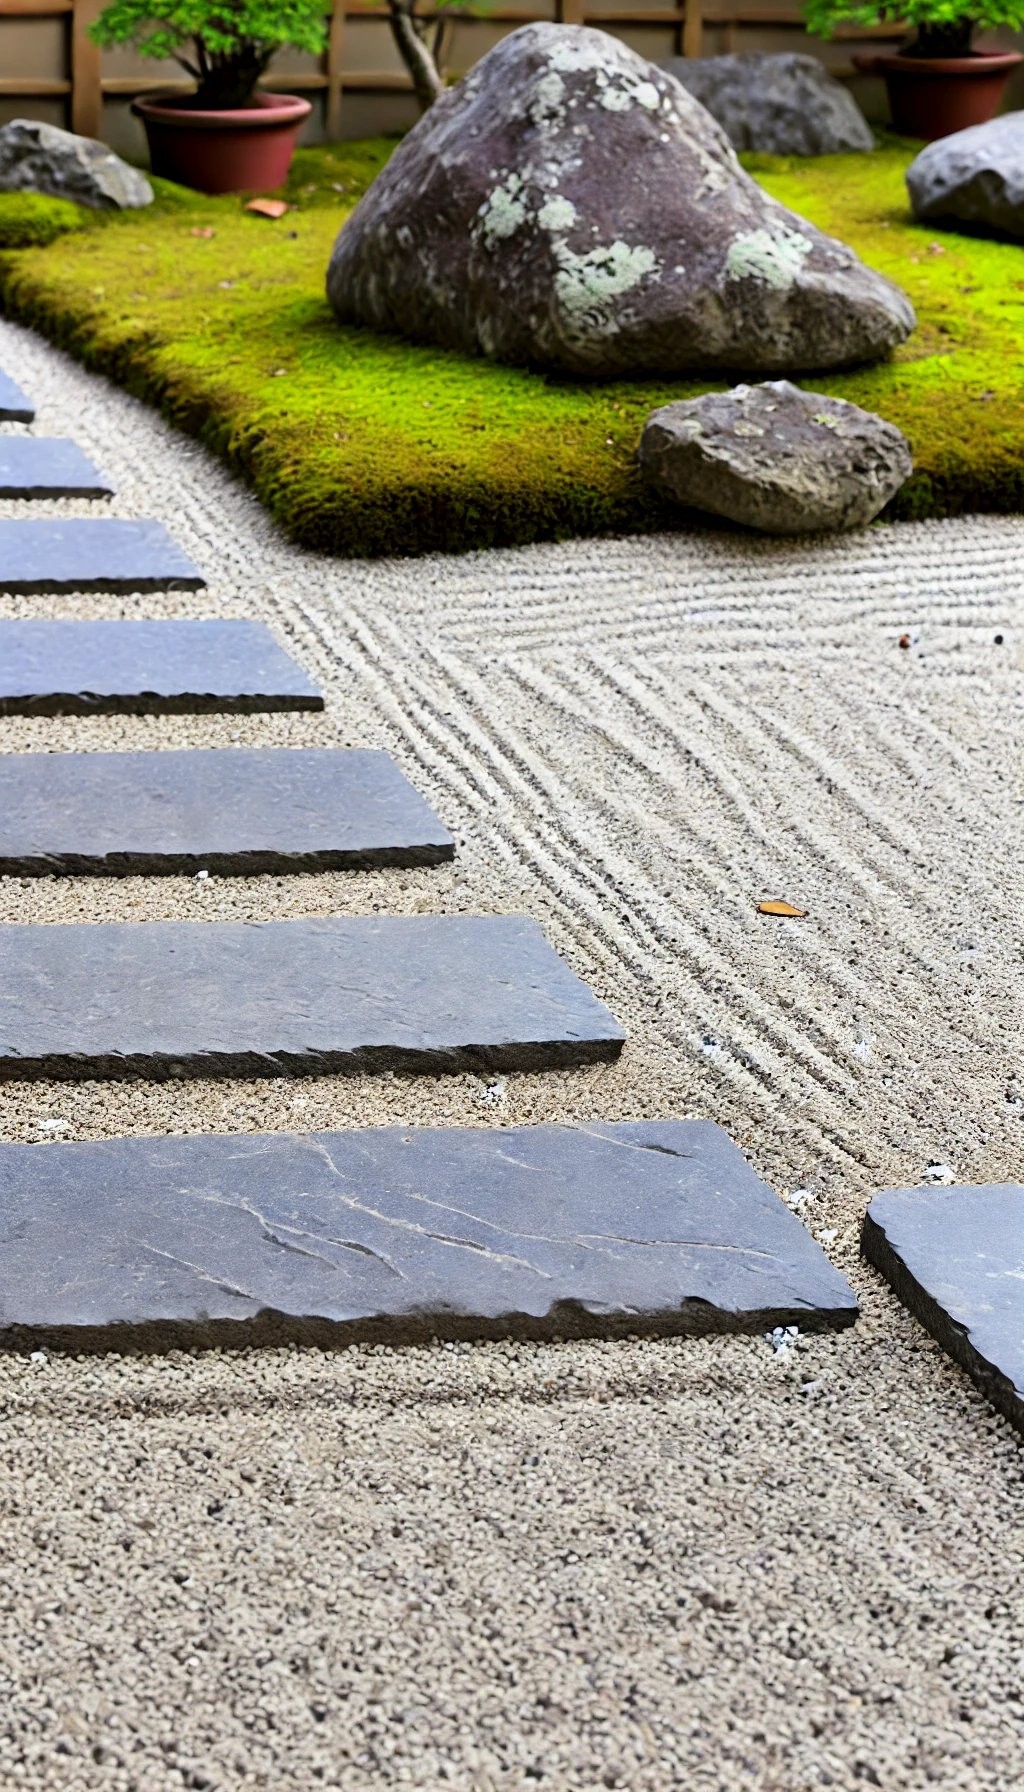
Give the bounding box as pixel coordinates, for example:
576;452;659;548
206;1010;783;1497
0;1120;857;1349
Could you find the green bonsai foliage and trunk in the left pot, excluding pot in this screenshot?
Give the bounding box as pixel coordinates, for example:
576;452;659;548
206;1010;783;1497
90;0;330;111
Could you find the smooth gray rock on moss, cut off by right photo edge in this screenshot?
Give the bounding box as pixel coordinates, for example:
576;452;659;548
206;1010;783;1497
907;111;1024;237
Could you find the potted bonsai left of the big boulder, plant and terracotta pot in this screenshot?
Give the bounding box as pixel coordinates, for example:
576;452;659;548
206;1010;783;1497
91;0;328;194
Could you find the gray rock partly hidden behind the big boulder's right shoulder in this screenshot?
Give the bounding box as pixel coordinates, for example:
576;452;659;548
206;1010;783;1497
665;52;875;156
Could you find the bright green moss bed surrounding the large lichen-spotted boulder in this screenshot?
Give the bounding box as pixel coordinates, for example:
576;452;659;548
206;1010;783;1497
0;140;1024;554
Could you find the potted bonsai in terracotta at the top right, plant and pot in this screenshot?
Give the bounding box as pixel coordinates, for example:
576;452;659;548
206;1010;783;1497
803;0;1024;143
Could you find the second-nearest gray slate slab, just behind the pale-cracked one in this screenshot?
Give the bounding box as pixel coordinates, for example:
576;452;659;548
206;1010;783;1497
0;916;624;1081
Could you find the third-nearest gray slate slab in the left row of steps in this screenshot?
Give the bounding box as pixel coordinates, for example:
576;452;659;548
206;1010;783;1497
0;747;456;876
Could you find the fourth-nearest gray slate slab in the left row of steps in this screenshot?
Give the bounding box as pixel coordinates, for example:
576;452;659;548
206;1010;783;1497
0;622;323;715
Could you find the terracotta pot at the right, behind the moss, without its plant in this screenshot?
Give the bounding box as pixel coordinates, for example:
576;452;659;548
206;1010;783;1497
854;50;1024;143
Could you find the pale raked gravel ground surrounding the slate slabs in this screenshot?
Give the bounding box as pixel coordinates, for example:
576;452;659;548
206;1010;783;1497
0;324;1024;1792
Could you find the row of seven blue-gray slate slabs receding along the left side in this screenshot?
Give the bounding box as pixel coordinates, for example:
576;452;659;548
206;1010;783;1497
0;356;857;1349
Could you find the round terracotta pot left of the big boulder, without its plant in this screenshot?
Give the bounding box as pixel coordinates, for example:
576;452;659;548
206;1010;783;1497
131;93;310;194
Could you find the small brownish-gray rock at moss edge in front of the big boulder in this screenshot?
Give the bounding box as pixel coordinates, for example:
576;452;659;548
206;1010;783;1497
640;380;913;536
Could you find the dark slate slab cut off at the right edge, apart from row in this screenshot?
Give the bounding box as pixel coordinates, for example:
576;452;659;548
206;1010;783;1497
861;1183;1024;1432
